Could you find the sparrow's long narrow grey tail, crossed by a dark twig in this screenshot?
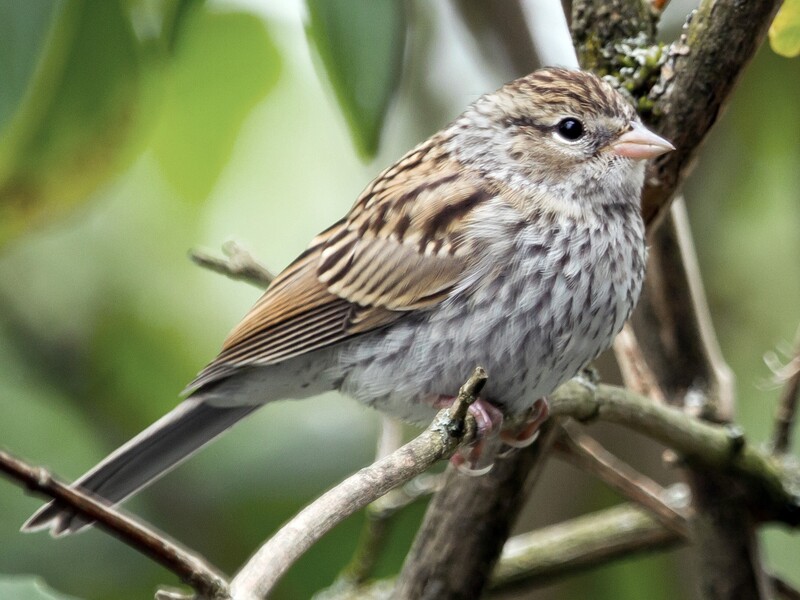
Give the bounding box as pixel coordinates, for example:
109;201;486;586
22;393;259;536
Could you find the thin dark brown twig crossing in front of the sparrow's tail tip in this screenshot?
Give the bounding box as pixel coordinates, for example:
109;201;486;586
0;450;230;600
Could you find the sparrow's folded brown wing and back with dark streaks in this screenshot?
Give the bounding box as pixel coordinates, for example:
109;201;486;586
187;139;493;393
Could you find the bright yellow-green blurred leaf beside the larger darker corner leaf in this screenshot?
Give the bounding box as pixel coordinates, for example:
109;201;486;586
152;7;280;201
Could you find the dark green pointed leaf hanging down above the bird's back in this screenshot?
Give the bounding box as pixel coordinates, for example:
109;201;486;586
306;0;406;158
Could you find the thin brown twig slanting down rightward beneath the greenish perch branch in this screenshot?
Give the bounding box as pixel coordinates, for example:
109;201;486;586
556;423;689;538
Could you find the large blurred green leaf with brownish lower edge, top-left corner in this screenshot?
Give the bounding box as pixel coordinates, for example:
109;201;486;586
0;0;169;243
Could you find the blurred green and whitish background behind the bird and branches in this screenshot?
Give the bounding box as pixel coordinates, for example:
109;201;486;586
0;0;800;600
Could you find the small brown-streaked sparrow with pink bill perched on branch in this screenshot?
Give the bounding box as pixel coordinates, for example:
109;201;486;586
23;68;674;535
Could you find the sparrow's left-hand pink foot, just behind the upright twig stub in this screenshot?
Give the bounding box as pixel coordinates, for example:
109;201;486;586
434;396;503;477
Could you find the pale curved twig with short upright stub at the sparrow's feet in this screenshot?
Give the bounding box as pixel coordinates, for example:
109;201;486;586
231;367;486;600
